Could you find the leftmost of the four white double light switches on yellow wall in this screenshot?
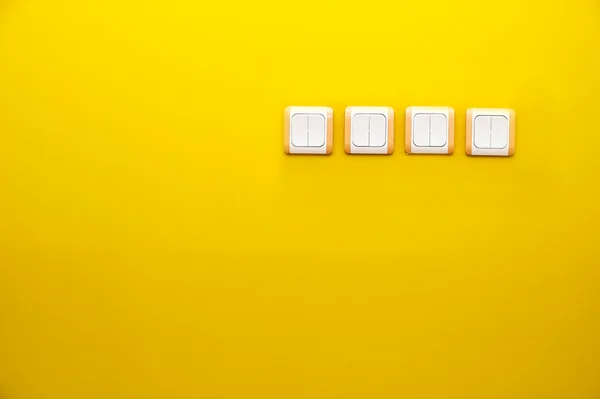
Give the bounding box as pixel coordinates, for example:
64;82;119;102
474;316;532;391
283;107;333;155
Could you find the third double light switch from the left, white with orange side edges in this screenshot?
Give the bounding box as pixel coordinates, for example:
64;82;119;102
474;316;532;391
404;107;454;154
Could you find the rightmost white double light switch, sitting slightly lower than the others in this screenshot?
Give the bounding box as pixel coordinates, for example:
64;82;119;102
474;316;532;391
465;108;515;157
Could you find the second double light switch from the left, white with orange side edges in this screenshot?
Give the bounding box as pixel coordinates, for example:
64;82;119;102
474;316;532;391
345;107;394;154
